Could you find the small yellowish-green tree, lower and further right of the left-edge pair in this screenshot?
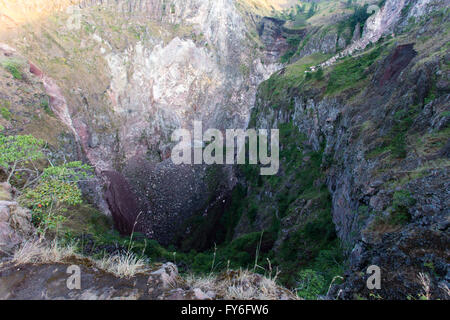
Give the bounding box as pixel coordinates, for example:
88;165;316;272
20;162;93;233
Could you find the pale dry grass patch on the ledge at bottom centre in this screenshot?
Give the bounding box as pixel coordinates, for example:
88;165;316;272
186;270;299;300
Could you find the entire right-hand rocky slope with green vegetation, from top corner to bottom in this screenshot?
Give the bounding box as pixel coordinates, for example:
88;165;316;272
230;1;450;299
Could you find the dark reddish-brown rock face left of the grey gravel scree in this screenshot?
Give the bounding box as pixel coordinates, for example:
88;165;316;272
102;171;140;235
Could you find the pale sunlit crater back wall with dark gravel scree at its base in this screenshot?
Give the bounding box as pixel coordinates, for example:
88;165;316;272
0;0;283;242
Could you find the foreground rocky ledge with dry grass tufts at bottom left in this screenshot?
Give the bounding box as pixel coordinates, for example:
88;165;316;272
0;183;297;300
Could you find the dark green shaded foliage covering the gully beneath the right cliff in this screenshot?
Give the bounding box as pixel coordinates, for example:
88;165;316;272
209;122;343;288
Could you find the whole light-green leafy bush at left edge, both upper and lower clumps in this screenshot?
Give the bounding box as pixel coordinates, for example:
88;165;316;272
0;134;92;232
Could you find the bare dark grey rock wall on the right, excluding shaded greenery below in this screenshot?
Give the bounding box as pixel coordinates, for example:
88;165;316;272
246;1;450;299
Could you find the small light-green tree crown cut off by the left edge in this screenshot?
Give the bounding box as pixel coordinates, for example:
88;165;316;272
0;134;45;183
